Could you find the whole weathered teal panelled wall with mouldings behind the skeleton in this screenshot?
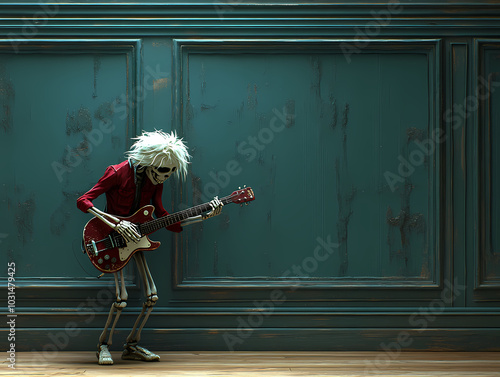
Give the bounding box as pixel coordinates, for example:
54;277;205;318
0;1;500;352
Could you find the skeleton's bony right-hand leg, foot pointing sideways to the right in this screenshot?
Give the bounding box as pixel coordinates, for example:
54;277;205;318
122;252;160;361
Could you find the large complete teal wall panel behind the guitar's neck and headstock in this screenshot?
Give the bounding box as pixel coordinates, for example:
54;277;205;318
175;40;442;296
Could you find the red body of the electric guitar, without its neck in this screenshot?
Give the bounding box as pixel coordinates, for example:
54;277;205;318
83;205;161;273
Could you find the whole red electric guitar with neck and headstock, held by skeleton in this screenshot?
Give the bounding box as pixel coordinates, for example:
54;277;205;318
82;187;255;276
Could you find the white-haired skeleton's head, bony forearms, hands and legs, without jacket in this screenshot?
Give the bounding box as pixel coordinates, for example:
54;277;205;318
78;131;223;365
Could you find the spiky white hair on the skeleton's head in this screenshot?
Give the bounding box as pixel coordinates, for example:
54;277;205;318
126;130;191;179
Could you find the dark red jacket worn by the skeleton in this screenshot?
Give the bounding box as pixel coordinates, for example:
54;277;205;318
76;161;182;233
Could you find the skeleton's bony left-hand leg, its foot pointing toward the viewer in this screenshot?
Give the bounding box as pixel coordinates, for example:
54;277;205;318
97;270;128;365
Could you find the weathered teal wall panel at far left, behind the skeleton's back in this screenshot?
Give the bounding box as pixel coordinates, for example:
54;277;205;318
0;39;141;297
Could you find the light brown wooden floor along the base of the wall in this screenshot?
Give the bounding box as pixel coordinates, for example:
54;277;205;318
0;351;500;377
